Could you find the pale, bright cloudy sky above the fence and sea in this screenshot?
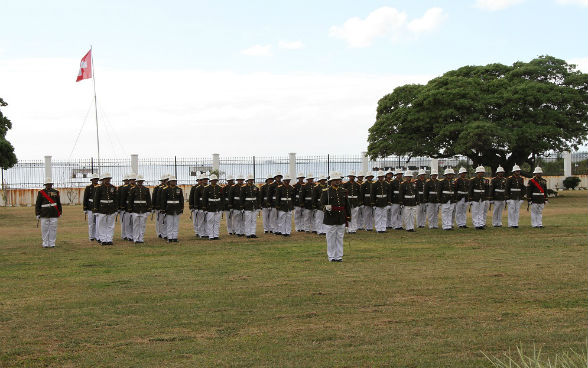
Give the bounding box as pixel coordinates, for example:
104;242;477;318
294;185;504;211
0;0;588;158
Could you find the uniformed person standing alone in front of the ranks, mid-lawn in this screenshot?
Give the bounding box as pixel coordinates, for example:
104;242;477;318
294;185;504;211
320;172;351;262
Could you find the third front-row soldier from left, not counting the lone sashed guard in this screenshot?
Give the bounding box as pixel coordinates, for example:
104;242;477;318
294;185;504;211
159;176;184;243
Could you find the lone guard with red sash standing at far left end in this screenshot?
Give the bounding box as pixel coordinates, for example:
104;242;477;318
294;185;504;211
35;178;62;248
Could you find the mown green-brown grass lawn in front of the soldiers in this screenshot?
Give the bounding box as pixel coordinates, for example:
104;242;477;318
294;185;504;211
0;191;588;367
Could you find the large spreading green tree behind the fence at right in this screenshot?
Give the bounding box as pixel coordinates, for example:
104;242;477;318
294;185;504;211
368;56;588;169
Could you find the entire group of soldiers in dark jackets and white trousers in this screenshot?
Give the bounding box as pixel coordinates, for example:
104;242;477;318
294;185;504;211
35;165;548;262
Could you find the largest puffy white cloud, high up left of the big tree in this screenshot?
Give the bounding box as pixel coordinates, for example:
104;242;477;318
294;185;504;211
329;6;447;47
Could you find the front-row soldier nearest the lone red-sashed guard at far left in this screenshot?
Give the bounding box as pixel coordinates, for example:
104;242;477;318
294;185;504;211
93;173;119;245
